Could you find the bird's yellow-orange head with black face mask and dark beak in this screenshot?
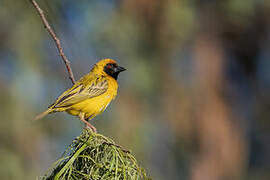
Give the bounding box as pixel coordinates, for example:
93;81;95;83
93;59;126;80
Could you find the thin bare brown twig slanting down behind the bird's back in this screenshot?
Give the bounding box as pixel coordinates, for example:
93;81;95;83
30;0;75;84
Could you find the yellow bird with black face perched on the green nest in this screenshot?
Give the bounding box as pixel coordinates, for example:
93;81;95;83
34;59;126;132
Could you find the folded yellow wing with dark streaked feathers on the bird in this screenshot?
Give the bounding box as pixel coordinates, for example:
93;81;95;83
49;76;108;109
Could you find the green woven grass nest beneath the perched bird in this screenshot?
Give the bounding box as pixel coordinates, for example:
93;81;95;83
42;129;150;180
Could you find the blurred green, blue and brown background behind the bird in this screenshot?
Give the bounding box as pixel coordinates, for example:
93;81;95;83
0;0;270;180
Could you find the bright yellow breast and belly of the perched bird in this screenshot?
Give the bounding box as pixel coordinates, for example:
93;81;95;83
67;77;118;118
